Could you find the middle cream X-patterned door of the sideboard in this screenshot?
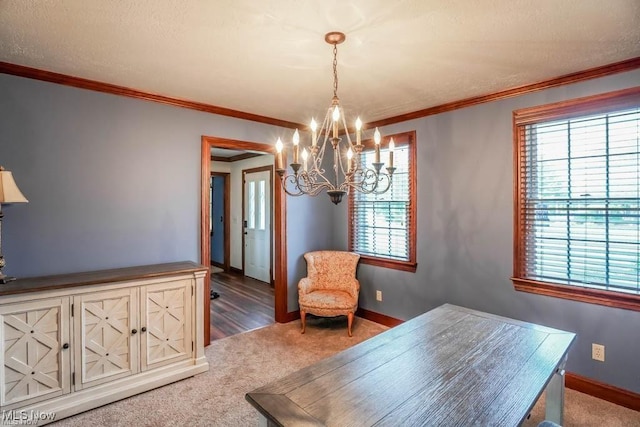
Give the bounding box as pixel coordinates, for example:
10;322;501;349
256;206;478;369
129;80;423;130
74;289;139;390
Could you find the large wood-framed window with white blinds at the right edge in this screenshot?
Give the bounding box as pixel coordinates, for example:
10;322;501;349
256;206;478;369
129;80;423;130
514;89;640;308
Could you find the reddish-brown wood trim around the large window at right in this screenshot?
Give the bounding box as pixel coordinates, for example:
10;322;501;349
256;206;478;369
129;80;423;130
511;86;640;311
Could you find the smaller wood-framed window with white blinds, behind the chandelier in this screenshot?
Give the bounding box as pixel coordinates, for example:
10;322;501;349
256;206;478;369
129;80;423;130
349;132;416;271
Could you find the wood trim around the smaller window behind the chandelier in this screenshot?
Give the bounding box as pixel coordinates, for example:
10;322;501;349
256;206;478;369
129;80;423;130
347;130;418;273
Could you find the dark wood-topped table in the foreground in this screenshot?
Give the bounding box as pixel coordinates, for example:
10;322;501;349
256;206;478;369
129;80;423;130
246;304;575;427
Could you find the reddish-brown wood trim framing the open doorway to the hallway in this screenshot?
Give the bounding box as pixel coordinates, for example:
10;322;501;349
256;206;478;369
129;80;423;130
200;135;288;345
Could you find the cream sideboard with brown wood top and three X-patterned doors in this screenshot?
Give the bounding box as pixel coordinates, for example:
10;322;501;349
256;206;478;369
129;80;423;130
0;262;209;424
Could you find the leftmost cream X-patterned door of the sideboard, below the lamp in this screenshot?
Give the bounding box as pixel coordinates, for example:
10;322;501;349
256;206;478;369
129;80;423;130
0;297;71;408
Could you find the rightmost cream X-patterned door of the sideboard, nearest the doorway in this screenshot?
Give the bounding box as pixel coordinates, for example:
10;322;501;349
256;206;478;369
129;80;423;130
141;280;192;370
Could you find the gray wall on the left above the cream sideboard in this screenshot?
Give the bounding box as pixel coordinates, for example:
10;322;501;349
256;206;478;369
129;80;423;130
0;74;322;308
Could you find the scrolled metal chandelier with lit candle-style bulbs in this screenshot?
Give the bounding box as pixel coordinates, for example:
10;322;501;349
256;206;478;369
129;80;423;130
276;32;396;205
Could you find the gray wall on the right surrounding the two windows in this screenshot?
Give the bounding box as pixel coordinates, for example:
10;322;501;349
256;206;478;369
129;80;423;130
333;71;640;392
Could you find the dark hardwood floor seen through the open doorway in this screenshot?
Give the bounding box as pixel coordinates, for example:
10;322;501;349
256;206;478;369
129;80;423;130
210;272;275;341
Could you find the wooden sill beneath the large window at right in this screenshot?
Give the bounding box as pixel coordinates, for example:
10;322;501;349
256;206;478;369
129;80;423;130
511;277;640;311
